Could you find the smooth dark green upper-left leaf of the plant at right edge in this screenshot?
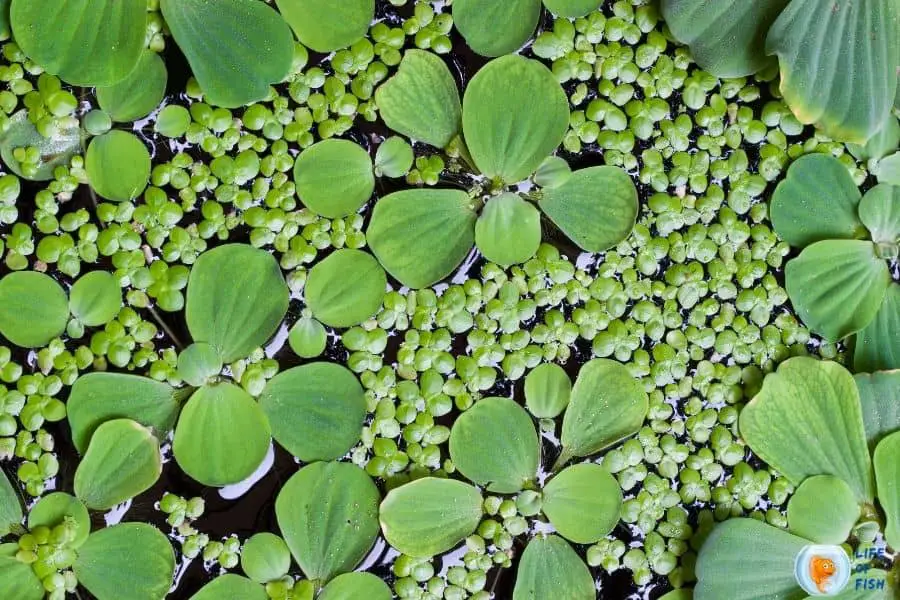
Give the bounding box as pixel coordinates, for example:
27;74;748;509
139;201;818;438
770;154;866;248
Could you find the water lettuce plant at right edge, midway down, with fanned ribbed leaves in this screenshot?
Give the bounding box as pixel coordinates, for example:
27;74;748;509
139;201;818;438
771;154;900;371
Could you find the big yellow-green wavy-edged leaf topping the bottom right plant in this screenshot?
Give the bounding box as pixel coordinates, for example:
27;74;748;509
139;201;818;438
740;356;872;502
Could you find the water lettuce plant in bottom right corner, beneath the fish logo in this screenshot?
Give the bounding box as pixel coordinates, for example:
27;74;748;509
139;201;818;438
694;357;900;600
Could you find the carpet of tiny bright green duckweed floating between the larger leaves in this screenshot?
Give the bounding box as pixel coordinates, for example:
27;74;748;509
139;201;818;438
0;0;892;600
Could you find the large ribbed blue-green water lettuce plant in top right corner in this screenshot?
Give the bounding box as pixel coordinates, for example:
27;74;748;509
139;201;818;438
662;0;900;144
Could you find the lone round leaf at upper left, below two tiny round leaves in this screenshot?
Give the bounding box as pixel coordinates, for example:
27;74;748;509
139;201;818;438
84;129;150;202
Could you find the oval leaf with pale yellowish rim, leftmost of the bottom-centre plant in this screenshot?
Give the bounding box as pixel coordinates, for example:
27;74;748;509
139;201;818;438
381;476;483;558
